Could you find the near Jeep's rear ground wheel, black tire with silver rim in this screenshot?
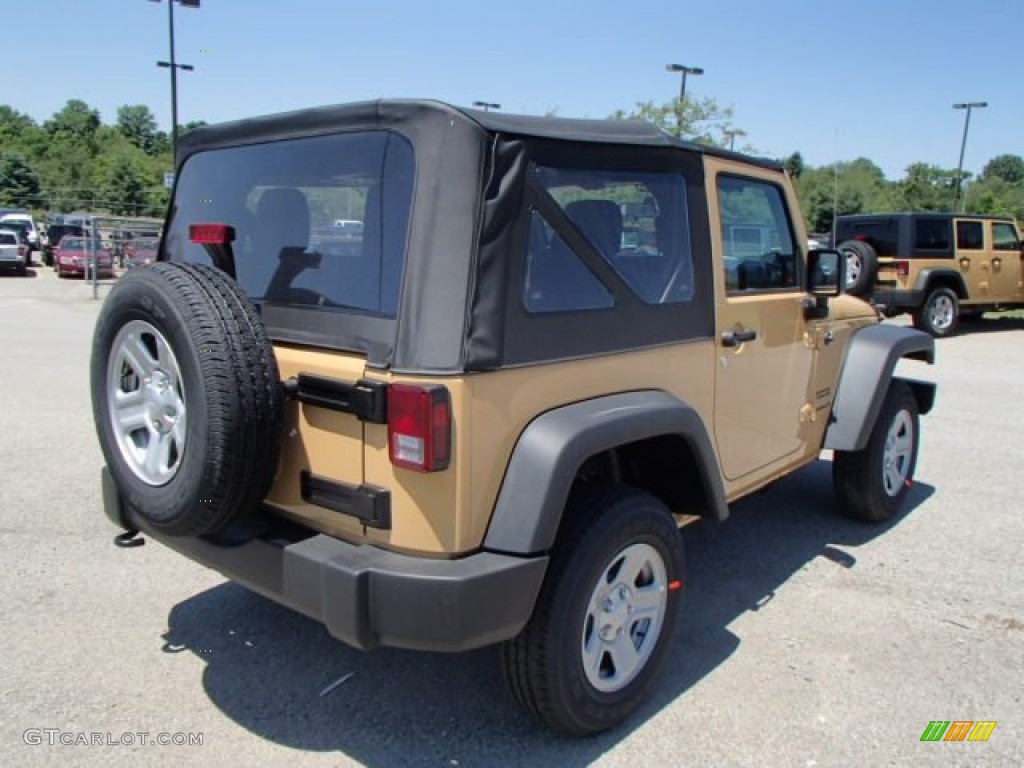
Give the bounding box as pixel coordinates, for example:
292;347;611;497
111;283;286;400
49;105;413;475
502;486;683;735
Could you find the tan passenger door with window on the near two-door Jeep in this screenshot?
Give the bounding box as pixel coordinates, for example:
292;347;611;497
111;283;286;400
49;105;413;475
706;158;815;485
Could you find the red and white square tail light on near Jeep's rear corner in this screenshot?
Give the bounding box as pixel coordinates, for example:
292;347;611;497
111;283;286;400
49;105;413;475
387;384;452;472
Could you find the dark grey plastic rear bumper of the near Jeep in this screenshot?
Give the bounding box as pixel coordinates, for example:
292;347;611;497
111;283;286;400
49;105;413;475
101;467;548;651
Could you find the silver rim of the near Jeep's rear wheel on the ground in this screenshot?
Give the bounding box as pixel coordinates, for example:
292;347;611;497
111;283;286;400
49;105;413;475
580;544;669;693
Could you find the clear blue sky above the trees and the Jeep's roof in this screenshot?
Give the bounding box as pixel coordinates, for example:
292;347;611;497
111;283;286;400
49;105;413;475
0;0;1024;178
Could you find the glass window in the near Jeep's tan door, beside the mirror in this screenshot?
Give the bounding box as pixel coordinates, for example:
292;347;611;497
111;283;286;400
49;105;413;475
718;176;799;293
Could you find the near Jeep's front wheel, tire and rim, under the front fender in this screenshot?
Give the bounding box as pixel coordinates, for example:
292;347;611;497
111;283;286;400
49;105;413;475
833;381;920;522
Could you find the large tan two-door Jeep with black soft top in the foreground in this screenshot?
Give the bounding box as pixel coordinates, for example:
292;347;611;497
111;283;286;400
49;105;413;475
91;100;935;734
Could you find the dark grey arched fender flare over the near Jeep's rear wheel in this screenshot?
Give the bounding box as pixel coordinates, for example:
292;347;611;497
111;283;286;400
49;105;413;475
483;390;728;555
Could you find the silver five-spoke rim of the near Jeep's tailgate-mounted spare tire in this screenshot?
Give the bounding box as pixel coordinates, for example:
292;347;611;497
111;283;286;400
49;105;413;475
106;321;187;485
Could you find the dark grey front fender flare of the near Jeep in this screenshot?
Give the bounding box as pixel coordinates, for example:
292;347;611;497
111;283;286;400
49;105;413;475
823;325;935;451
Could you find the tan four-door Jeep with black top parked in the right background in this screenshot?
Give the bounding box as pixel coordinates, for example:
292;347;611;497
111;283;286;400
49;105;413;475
836;213;1024;338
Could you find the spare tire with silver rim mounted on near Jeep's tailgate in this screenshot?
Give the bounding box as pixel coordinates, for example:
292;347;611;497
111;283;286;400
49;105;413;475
90;262;282;536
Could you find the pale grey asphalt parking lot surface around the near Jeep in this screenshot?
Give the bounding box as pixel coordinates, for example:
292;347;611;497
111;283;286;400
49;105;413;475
0;267;1024;768
